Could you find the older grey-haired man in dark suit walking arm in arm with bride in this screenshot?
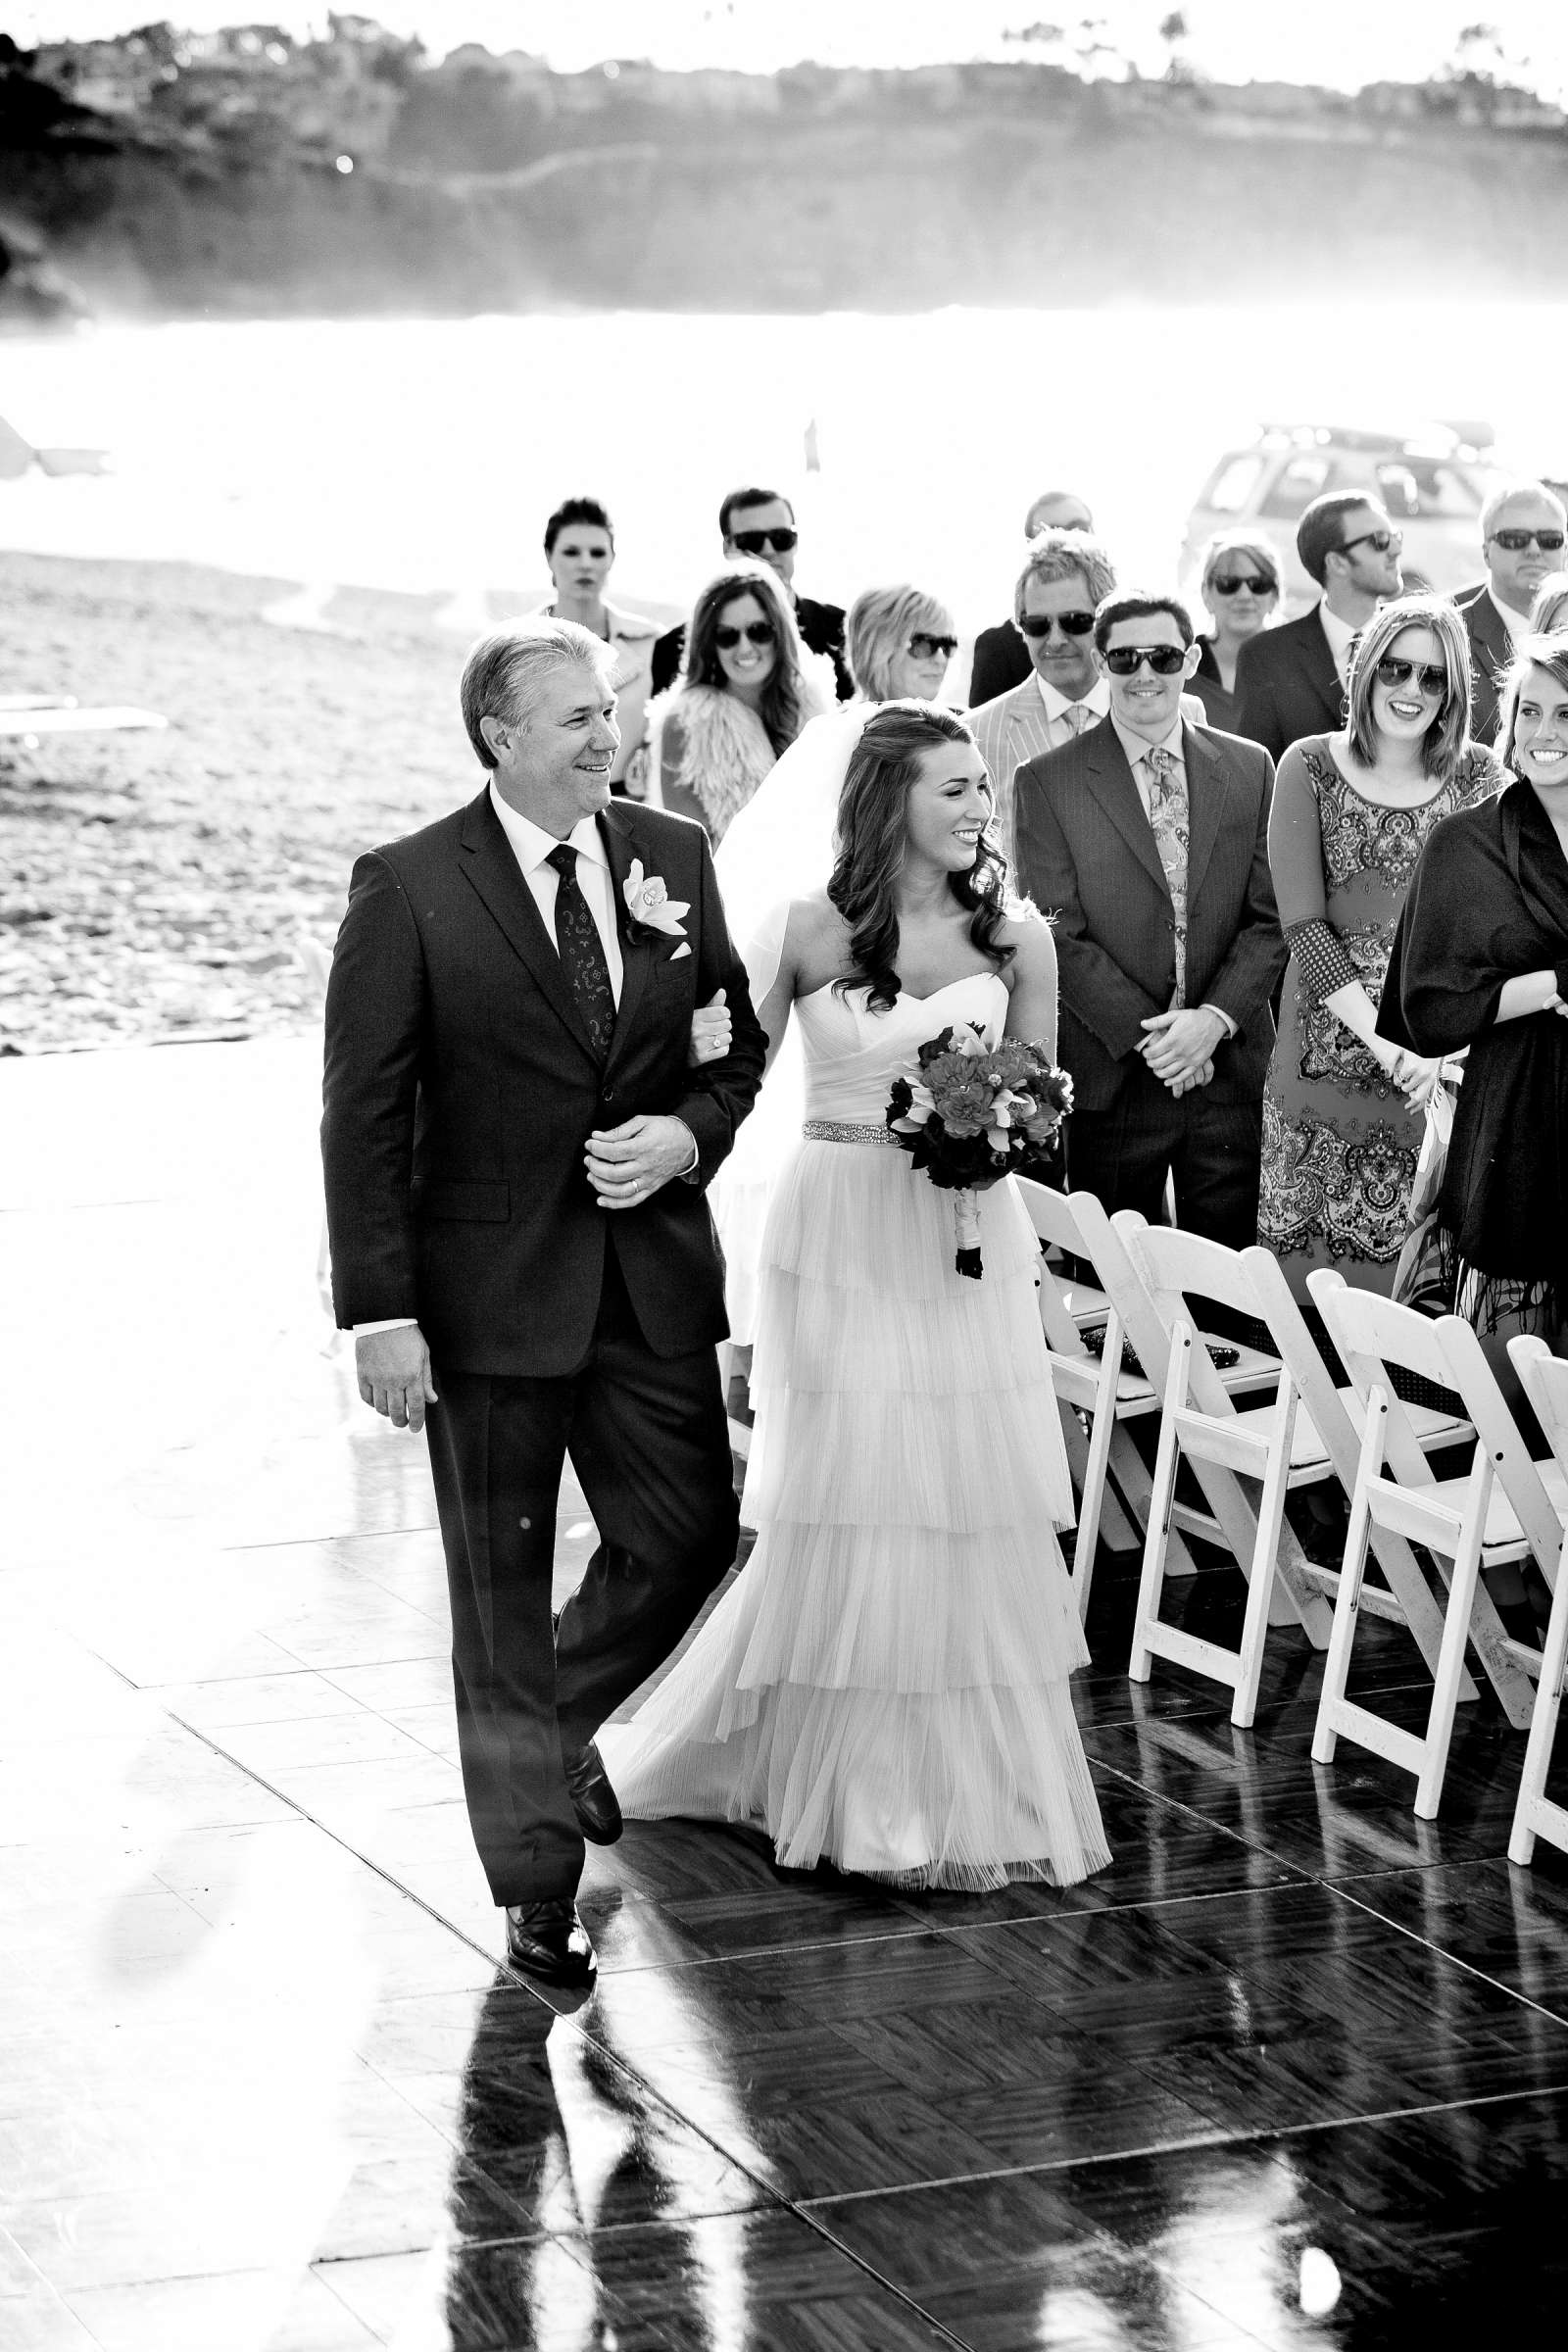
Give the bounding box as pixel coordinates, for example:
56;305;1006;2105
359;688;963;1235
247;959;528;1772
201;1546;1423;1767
322;618;766;1985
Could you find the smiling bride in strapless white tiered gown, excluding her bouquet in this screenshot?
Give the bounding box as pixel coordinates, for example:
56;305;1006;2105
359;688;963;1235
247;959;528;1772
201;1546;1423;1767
600;704;1109;1891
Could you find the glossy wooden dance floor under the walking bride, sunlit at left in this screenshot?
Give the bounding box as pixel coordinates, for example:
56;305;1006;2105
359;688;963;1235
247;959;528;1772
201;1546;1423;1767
0;1042;1568;2352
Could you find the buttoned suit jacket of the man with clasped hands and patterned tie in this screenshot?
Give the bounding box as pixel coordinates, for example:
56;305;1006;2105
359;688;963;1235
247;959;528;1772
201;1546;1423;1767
1015;719;1286;1110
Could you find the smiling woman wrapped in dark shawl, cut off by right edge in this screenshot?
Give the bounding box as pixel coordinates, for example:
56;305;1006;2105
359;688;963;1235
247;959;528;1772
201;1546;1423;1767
1378;635;1568;1354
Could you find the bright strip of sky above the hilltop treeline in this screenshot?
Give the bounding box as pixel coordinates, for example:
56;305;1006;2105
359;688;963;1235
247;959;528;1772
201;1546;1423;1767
5;0;1568;96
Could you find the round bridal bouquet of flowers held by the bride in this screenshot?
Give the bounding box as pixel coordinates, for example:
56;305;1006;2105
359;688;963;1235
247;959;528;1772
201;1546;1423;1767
886;1021;1072;1282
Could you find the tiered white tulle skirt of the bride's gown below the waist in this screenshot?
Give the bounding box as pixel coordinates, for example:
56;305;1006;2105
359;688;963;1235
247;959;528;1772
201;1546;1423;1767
600;1143;1109;1888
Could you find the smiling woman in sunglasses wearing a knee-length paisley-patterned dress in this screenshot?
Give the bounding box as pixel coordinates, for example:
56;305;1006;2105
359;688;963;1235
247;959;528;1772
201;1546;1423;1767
1257;595;1502;1329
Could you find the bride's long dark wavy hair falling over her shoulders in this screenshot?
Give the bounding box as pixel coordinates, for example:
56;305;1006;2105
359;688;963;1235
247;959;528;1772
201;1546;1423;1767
827;701;1018;1009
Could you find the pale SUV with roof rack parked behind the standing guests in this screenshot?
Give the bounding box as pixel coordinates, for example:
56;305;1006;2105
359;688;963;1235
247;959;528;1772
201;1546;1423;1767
1180;418;1499;616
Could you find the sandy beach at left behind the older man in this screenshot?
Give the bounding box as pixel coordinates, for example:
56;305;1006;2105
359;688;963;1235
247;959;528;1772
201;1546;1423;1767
0;555;522;1054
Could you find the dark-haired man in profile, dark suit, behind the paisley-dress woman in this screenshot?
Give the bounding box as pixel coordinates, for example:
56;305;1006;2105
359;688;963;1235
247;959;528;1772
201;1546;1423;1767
1237;489;1403;760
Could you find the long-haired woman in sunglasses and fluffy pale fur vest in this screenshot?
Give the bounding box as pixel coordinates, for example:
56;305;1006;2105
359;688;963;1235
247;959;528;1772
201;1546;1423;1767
649;563;837;849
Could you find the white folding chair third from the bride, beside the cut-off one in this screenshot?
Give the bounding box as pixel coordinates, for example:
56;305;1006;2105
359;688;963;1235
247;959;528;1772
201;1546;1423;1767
1307;1268;1568;1821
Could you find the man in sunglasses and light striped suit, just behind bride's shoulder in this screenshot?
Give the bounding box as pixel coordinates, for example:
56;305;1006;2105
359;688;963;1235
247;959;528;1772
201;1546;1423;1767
968;529;1116;857
